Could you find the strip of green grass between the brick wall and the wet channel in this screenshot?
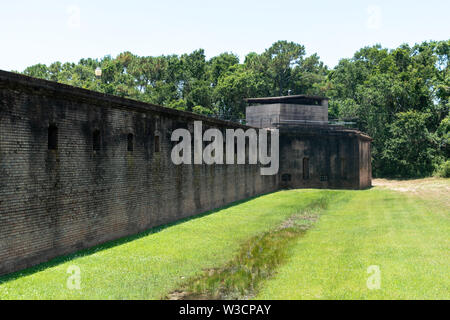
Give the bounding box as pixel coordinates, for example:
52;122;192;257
0;191;330;299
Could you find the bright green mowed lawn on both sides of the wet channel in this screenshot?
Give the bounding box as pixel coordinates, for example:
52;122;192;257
0;179;450;299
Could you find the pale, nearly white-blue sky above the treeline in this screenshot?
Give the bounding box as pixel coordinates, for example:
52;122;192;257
0;0;450;71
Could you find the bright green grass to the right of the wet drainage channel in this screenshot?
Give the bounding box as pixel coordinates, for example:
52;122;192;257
257;189;450;299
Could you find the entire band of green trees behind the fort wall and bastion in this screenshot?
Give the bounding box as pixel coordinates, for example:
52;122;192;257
20;40;450;177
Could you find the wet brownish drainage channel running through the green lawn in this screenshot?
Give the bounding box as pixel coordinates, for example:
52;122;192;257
165;197;329;300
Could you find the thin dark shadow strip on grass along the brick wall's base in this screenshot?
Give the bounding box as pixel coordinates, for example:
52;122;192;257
0;191;277;285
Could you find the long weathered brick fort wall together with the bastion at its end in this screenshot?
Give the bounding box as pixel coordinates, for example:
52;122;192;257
0;71;370;274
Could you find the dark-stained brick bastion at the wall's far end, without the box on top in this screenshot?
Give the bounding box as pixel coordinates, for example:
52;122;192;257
279;126;372;189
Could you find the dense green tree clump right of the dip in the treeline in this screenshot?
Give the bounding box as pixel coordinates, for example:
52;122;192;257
327;41;450;177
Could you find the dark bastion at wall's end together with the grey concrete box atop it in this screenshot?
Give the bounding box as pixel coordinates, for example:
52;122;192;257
246;95;372;189
